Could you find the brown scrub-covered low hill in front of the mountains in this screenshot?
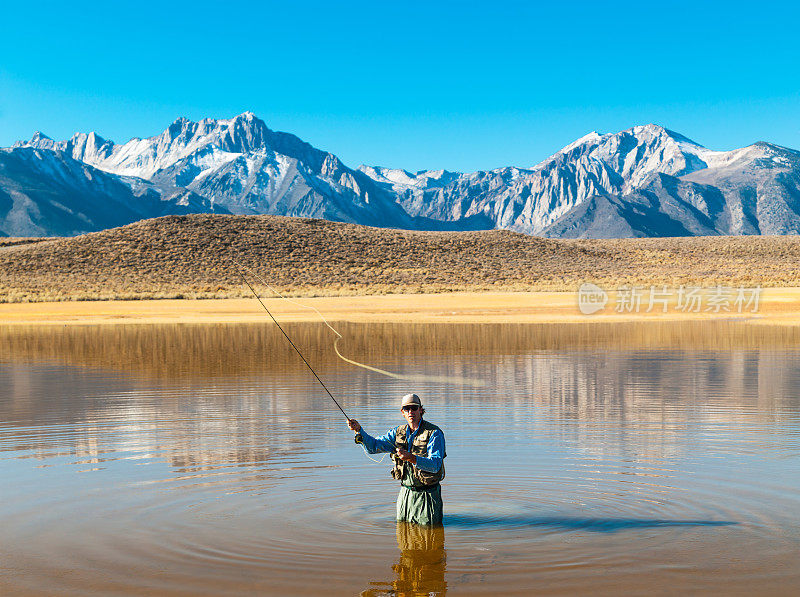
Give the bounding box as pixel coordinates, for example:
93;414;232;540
0;215;800;302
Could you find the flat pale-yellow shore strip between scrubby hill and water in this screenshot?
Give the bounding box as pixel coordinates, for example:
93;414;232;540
0;288;800;326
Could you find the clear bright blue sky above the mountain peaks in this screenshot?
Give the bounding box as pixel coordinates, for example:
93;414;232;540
0;0;800;171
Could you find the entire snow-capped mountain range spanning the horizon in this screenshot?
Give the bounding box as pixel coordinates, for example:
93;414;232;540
0;112;800;238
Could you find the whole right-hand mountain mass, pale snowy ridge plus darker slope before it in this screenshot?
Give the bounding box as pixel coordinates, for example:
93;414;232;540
360;124;797;237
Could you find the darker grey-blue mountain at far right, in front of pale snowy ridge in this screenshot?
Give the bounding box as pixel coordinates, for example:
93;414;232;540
541;143;800;238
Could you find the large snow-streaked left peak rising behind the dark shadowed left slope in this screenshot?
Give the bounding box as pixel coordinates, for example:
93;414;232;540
15;112;422;234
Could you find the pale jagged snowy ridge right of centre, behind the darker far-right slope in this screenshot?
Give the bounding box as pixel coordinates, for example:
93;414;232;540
359;124;717;234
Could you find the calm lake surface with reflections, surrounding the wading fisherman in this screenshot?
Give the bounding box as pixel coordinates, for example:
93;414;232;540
0;323;800;595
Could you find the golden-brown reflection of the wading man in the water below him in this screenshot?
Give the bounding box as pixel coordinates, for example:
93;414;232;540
361;522;447;597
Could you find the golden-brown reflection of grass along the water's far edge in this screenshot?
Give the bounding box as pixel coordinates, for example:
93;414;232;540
0;321;800;378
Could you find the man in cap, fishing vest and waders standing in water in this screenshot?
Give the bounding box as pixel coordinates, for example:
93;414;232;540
348;394;447;525
